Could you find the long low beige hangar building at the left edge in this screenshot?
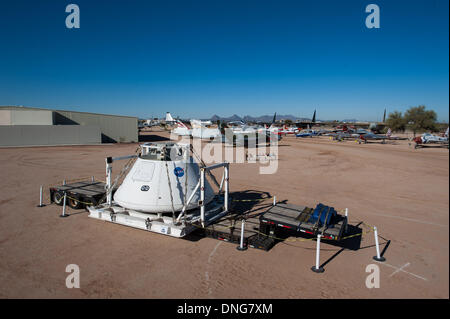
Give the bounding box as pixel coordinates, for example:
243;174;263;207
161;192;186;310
0;106;138;146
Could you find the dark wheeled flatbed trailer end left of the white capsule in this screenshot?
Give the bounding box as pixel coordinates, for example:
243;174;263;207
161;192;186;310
49;180;111;209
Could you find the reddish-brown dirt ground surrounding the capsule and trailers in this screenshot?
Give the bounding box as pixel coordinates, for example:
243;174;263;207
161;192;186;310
0;132;449;298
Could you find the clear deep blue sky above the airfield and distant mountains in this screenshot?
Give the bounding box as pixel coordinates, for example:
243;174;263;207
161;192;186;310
0;0;449;121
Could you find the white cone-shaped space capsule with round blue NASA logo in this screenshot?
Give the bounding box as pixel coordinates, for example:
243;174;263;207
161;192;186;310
114;143;214;213
